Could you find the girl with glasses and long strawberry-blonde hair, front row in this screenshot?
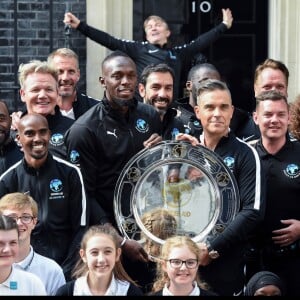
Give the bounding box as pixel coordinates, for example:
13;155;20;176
149;236;217;296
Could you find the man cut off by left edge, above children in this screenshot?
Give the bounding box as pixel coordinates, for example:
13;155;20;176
0;100;23;175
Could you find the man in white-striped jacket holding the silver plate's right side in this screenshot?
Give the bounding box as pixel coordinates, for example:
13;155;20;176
177;79;265;296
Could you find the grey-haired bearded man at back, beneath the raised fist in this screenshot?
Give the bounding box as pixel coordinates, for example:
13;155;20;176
48;48;99;120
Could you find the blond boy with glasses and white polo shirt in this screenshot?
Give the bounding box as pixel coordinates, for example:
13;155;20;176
0;192;66;296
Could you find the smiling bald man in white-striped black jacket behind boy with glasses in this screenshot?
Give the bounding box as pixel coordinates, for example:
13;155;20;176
0;113;87;279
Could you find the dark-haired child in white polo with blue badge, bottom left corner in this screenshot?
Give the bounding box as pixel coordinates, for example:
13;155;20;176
0;213;46;296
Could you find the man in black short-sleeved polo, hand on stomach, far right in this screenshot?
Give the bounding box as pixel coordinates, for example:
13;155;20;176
248;90;300;296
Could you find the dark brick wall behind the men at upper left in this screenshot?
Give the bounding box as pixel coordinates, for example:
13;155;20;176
0;0;86;111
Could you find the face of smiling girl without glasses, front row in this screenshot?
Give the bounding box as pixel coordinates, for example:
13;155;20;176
80;234;121;277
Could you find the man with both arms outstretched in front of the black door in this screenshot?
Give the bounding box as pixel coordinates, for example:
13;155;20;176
64;8;233;99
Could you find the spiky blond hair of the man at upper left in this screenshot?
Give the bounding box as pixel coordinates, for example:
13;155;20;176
18;60;58;89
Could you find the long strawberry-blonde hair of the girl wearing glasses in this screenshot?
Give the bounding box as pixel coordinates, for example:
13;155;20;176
152;235;208;292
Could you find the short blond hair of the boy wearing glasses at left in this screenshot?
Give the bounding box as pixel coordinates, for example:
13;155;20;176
0;192;38;218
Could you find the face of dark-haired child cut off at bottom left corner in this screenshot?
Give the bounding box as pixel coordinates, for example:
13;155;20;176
0;229;19;270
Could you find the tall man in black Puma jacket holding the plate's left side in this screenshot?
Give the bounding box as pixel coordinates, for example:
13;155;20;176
65;51;161;268
